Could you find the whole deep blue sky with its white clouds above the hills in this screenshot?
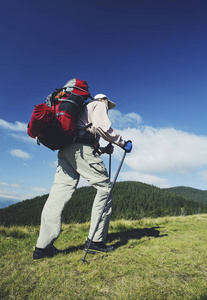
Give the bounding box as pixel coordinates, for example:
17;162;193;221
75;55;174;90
0;0;207;206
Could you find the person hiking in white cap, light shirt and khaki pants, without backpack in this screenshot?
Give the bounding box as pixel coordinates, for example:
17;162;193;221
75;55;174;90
33;94;132;260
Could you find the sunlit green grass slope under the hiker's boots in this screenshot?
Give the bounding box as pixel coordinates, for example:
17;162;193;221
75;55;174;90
0;214;207;300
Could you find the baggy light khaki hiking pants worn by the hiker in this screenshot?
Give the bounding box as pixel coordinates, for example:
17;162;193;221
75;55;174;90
37;144;112;248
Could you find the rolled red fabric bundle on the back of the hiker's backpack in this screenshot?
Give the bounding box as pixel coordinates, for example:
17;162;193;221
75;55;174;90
27;103;54;138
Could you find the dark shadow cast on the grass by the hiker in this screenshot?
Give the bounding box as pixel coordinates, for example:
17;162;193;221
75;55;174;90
64;227;167;254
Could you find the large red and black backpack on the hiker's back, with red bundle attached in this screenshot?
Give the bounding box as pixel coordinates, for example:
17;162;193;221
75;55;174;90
27;78;91;150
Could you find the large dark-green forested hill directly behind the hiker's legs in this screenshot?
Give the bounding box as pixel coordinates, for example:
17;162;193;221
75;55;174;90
0;181;207;226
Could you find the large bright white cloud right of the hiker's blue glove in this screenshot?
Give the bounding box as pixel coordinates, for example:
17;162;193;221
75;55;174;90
116;127;207;174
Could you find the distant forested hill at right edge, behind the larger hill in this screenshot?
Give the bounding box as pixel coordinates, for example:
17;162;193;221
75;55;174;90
166;186;207;203
